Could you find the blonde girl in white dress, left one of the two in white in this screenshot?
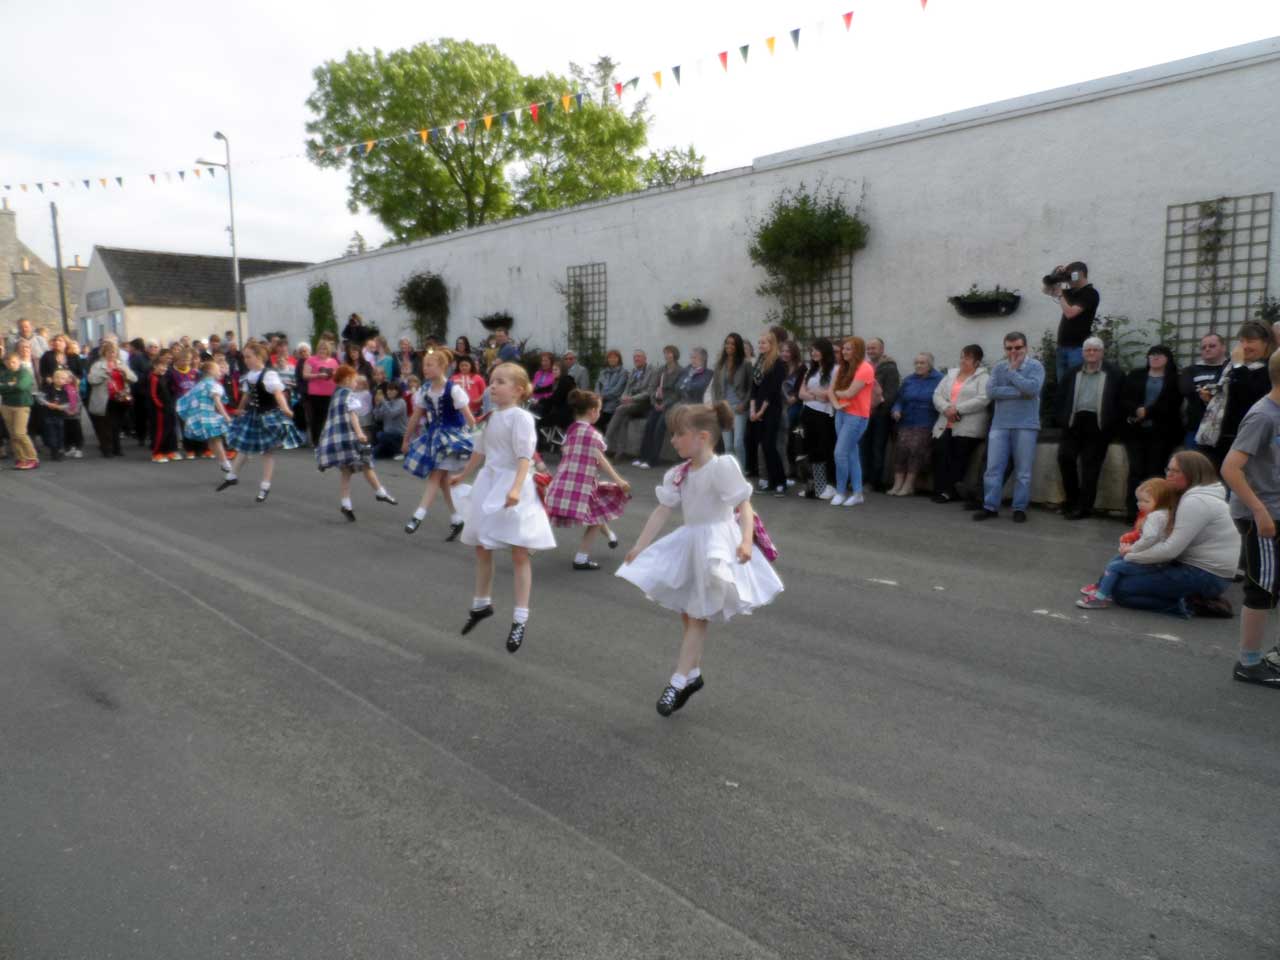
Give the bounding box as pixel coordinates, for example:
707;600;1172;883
451;364;556;653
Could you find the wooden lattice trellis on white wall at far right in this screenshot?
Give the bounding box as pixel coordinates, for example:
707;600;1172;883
1162;193;1274;357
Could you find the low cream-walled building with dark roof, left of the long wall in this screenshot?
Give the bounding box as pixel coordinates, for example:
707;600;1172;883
76;246;310;343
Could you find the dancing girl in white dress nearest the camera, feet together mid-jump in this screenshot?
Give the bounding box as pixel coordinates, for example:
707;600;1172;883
617;401;782;717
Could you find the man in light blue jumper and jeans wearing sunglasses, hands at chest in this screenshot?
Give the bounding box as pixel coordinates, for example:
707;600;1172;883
973;332;1044;524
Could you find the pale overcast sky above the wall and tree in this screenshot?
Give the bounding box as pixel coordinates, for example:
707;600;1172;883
0;0;1280;271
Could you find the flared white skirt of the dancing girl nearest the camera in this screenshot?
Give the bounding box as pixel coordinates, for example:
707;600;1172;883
616;522;782;620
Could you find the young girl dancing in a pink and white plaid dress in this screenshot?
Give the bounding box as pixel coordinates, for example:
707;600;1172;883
545;390;631;570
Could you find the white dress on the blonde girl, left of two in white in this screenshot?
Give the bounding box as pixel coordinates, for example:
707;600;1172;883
454;407;556;550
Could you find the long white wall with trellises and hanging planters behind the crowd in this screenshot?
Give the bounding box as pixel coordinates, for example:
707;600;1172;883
246;38;1280;365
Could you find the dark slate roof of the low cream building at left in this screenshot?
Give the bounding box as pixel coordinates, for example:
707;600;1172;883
96;247;311;310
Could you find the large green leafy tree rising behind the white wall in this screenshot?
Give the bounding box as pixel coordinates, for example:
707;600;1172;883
307;38;703;242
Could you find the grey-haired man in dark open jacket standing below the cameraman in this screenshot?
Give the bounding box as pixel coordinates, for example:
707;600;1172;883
1057;337;1123;520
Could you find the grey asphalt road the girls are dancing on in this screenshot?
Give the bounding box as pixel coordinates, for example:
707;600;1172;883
0;451;1280;960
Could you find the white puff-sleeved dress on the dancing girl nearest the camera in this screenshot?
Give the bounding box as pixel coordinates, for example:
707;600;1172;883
617;456;782;620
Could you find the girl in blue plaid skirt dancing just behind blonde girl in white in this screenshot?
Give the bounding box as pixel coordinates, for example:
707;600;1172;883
401;347;476;543
